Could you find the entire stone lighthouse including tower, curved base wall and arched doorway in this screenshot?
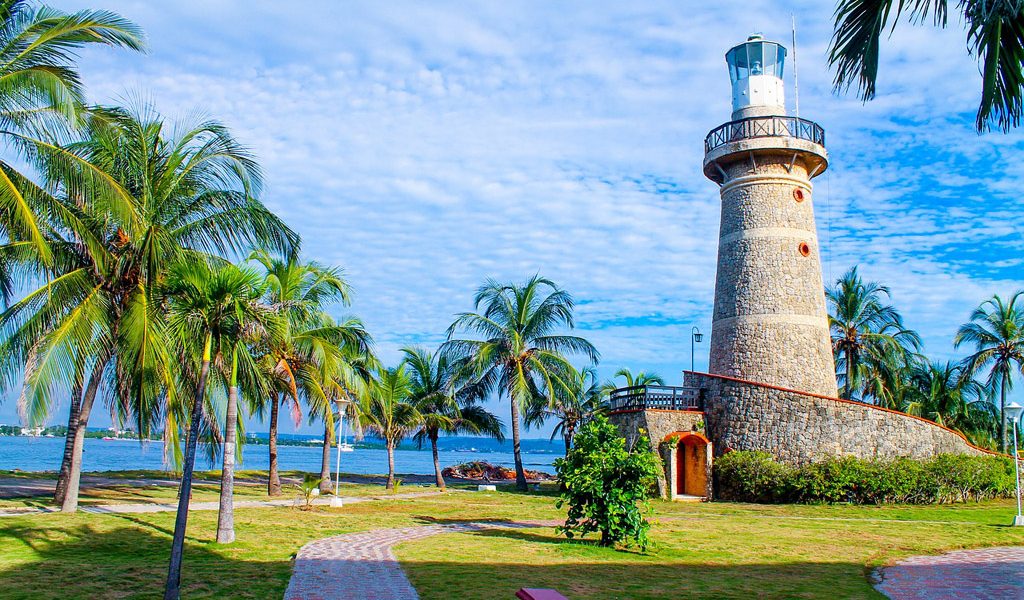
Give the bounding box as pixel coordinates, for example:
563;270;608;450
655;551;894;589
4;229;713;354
609;36;982;499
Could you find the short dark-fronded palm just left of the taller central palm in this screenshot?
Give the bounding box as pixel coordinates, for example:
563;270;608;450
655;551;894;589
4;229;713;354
401;347;505;489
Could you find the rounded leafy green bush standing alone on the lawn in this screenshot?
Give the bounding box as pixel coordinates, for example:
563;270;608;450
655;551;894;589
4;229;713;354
555;416;662;550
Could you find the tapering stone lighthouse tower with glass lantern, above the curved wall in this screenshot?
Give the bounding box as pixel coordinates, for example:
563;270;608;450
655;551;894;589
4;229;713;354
703;35;837;397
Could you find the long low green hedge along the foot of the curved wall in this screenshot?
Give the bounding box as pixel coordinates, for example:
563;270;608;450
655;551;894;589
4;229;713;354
715;451;1015;504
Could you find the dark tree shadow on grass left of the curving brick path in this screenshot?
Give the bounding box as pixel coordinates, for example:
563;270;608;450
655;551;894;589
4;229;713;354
0;515;291;600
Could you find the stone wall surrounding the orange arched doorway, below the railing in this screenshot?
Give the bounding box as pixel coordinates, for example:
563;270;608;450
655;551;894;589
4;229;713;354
608;410;714;500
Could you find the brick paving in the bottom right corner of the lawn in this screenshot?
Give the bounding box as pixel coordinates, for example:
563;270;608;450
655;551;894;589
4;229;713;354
876;547;1024;600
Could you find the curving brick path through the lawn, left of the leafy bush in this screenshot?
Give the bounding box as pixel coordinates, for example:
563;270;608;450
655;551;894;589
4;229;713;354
285;521;557;600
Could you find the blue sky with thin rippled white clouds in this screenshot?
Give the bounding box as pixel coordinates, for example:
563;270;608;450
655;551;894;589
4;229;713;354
0;0;1024;436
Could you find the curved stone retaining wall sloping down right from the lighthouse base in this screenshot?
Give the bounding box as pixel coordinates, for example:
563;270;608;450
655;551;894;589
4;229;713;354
685;372;992;464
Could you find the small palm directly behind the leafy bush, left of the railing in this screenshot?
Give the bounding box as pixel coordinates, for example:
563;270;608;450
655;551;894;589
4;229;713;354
525;367;606;455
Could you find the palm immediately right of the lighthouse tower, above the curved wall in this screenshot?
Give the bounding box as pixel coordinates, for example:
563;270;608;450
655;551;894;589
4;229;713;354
825;266;921;399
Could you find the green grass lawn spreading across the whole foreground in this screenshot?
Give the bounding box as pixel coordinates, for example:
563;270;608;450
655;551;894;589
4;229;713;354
0;487;1024;599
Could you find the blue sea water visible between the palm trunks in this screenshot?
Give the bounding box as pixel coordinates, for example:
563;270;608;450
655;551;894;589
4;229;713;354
0;436;564;475
